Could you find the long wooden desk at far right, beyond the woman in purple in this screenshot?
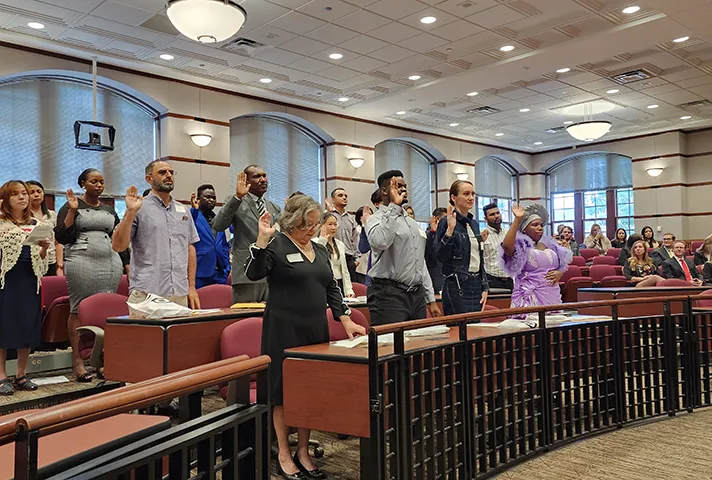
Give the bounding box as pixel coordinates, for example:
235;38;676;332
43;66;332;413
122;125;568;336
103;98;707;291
578;286;709;317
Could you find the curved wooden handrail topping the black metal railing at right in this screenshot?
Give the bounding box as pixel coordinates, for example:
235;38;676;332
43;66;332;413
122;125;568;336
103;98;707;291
369;295;712;335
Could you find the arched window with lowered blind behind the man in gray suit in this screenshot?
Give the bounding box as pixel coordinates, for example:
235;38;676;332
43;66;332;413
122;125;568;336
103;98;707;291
230;115;324;205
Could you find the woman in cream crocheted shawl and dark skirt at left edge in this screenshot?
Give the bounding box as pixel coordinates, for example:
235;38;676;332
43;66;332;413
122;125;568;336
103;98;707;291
0;180;49;395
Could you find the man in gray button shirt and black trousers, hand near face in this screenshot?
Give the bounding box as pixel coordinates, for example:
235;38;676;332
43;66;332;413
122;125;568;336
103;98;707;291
366;170;442;325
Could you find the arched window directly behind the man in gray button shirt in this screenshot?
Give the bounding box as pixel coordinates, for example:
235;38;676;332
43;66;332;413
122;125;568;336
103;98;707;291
375;139;436;222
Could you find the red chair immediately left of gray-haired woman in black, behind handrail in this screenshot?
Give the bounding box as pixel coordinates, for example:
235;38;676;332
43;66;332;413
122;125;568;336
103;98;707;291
220;317;262;403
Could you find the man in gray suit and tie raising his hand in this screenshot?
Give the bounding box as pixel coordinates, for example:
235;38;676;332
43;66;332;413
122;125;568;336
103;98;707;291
213;165;281;303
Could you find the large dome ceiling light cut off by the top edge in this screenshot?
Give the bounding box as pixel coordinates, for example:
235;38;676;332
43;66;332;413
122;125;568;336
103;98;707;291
166;0;247;44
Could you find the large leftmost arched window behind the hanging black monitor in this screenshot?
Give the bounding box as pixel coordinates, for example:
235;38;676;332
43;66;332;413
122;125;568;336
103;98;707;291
0;75;159;212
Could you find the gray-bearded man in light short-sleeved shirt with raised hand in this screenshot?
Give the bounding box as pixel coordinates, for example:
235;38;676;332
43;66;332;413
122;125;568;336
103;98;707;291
112;160;200;309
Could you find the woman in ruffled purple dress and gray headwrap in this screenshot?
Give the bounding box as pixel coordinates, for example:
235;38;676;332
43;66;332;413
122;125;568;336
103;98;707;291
499;203;572;318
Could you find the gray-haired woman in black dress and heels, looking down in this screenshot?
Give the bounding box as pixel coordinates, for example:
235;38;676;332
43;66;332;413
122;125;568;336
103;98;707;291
245;195;366;479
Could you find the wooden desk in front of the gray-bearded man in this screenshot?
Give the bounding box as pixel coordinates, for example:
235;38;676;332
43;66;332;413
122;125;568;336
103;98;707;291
104;308;264;383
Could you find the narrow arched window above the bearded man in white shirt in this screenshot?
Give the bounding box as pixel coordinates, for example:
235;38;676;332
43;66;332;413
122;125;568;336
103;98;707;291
472;156;515;230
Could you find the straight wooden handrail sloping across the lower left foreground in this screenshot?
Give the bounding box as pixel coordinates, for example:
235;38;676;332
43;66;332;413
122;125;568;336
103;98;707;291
0;355;270;439
